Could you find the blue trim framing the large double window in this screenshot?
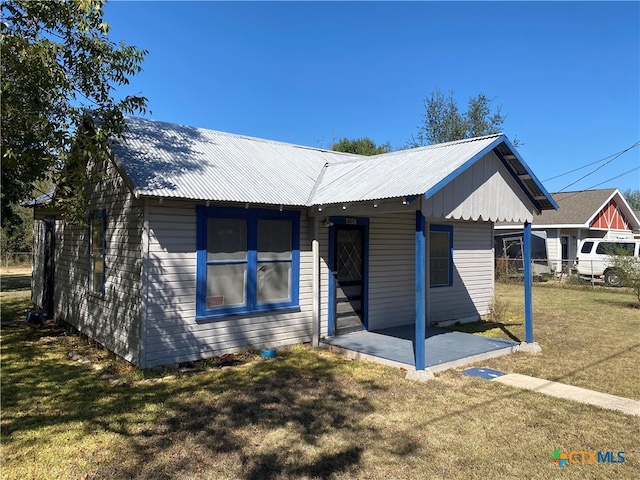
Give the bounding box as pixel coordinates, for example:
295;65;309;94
196;206;300;321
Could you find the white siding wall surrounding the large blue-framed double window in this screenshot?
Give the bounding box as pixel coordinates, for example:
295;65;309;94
143;201;318;367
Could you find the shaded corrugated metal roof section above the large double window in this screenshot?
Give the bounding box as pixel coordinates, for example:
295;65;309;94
113;118;359;205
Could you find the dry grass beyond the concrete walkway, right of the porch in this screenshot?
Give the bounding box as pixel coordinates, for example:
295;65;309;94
450;284;640;400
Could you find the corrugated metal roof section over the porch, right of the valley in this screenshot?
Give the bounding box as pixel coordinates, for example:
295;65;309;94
312;135;501;205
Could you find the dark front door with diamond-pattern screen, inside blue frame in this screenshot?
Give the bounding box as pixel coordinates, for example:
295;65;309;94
333;225;366;335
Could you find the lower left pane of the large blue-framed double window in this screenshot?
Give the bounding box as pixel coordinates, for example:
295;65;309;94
205;263;247;310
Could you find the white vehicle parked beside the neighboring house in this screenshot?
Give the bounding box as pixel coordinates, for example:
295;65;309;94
574;238;640;287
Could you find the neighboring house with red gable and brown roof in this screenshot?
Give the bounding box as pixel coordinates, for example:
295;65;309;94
495;188;640;272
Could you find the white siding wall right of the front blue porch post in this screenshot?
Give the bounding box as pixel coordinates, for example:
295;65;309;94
427;219;494;322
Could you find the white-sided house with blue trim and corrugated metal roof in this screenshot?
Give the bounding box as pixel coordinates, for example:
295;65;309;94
33;119;555;369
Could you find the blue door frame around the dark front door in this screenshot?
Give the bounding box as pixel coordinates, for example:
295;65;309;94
327;216;369;337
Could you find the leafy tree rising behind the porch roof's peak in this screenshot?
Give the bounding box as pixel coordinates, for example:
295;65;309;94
407;88;520;148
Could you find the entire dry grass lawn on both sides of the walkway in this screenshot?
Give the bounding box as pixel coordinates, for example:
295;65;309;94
0;274;640;479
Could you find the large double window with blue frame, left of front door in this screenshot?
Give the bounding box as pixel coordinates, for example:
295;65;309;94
196;207;300;319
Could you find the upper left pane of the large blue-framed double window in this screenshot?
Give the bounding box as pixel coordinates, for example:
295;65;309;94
207;218;247;260
